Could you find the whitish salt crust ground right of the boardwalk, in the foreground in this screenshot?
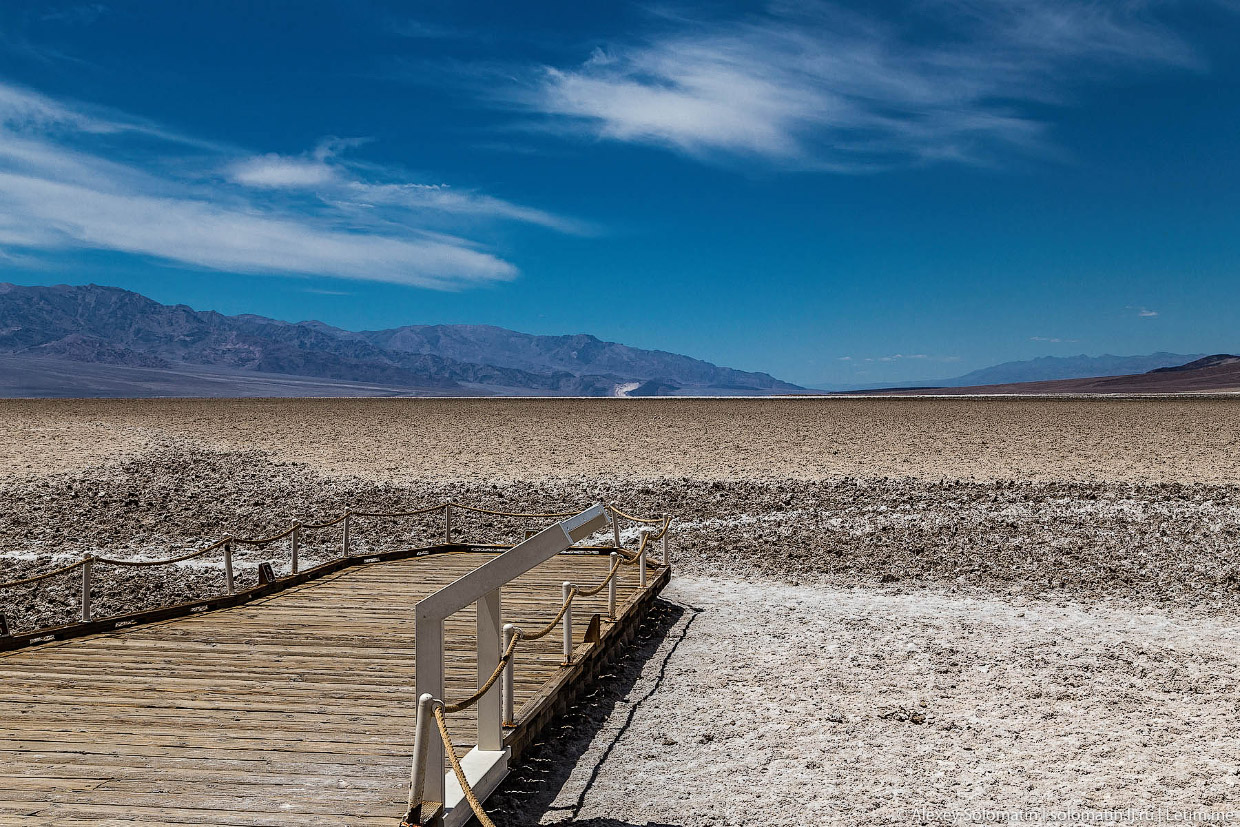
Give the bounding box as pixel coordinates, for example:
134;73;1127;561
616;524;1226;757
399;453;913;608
492;578;1240;827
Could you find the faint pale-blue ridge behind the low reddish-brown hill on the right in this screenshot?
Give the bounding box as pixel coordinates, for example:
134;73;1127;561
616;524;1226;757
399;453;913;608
815;352;1203;391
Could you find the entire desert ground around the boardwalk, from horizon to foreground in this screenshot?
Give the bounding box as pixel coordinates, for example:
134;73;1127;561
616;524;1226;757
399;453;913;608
0;398;1240;827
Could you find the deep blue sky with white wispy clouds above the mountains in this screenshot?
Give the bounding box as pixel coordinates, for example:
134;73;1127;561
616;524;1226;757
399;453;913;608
0;0;1240;383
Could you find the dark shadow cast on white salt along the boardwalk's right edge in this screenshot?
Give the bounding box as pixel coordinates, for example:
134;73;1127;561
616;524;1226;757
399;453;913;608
486;599;699;827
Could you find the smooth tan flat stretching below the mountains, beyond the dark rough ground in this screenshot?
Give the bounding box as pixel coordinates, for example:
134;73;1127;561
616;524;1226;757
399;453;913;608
0;397;1240;484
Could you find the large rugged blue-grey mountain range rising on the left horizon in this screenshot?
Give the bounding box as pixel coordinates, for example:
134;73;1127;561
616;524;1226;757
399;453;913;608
0;284;800;396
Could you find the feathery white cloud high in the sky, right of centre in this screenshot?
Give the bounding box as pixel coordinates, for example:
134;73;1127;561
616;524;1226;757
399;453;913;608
508;0;1199;171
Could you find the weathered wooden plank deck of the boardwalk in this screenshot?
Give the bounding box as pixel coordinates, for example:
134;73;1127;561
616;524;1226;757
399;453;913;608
0;551;660;827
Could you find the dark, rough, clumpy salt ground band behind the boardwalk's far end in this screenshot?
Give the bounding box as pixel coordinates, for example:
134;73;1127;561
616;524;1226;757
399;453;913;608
7;446;1240;629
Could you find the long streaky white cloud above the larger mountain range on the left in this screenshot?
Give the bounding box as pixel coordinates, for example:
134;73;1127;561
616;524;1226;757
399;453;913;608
0;82;570;289
